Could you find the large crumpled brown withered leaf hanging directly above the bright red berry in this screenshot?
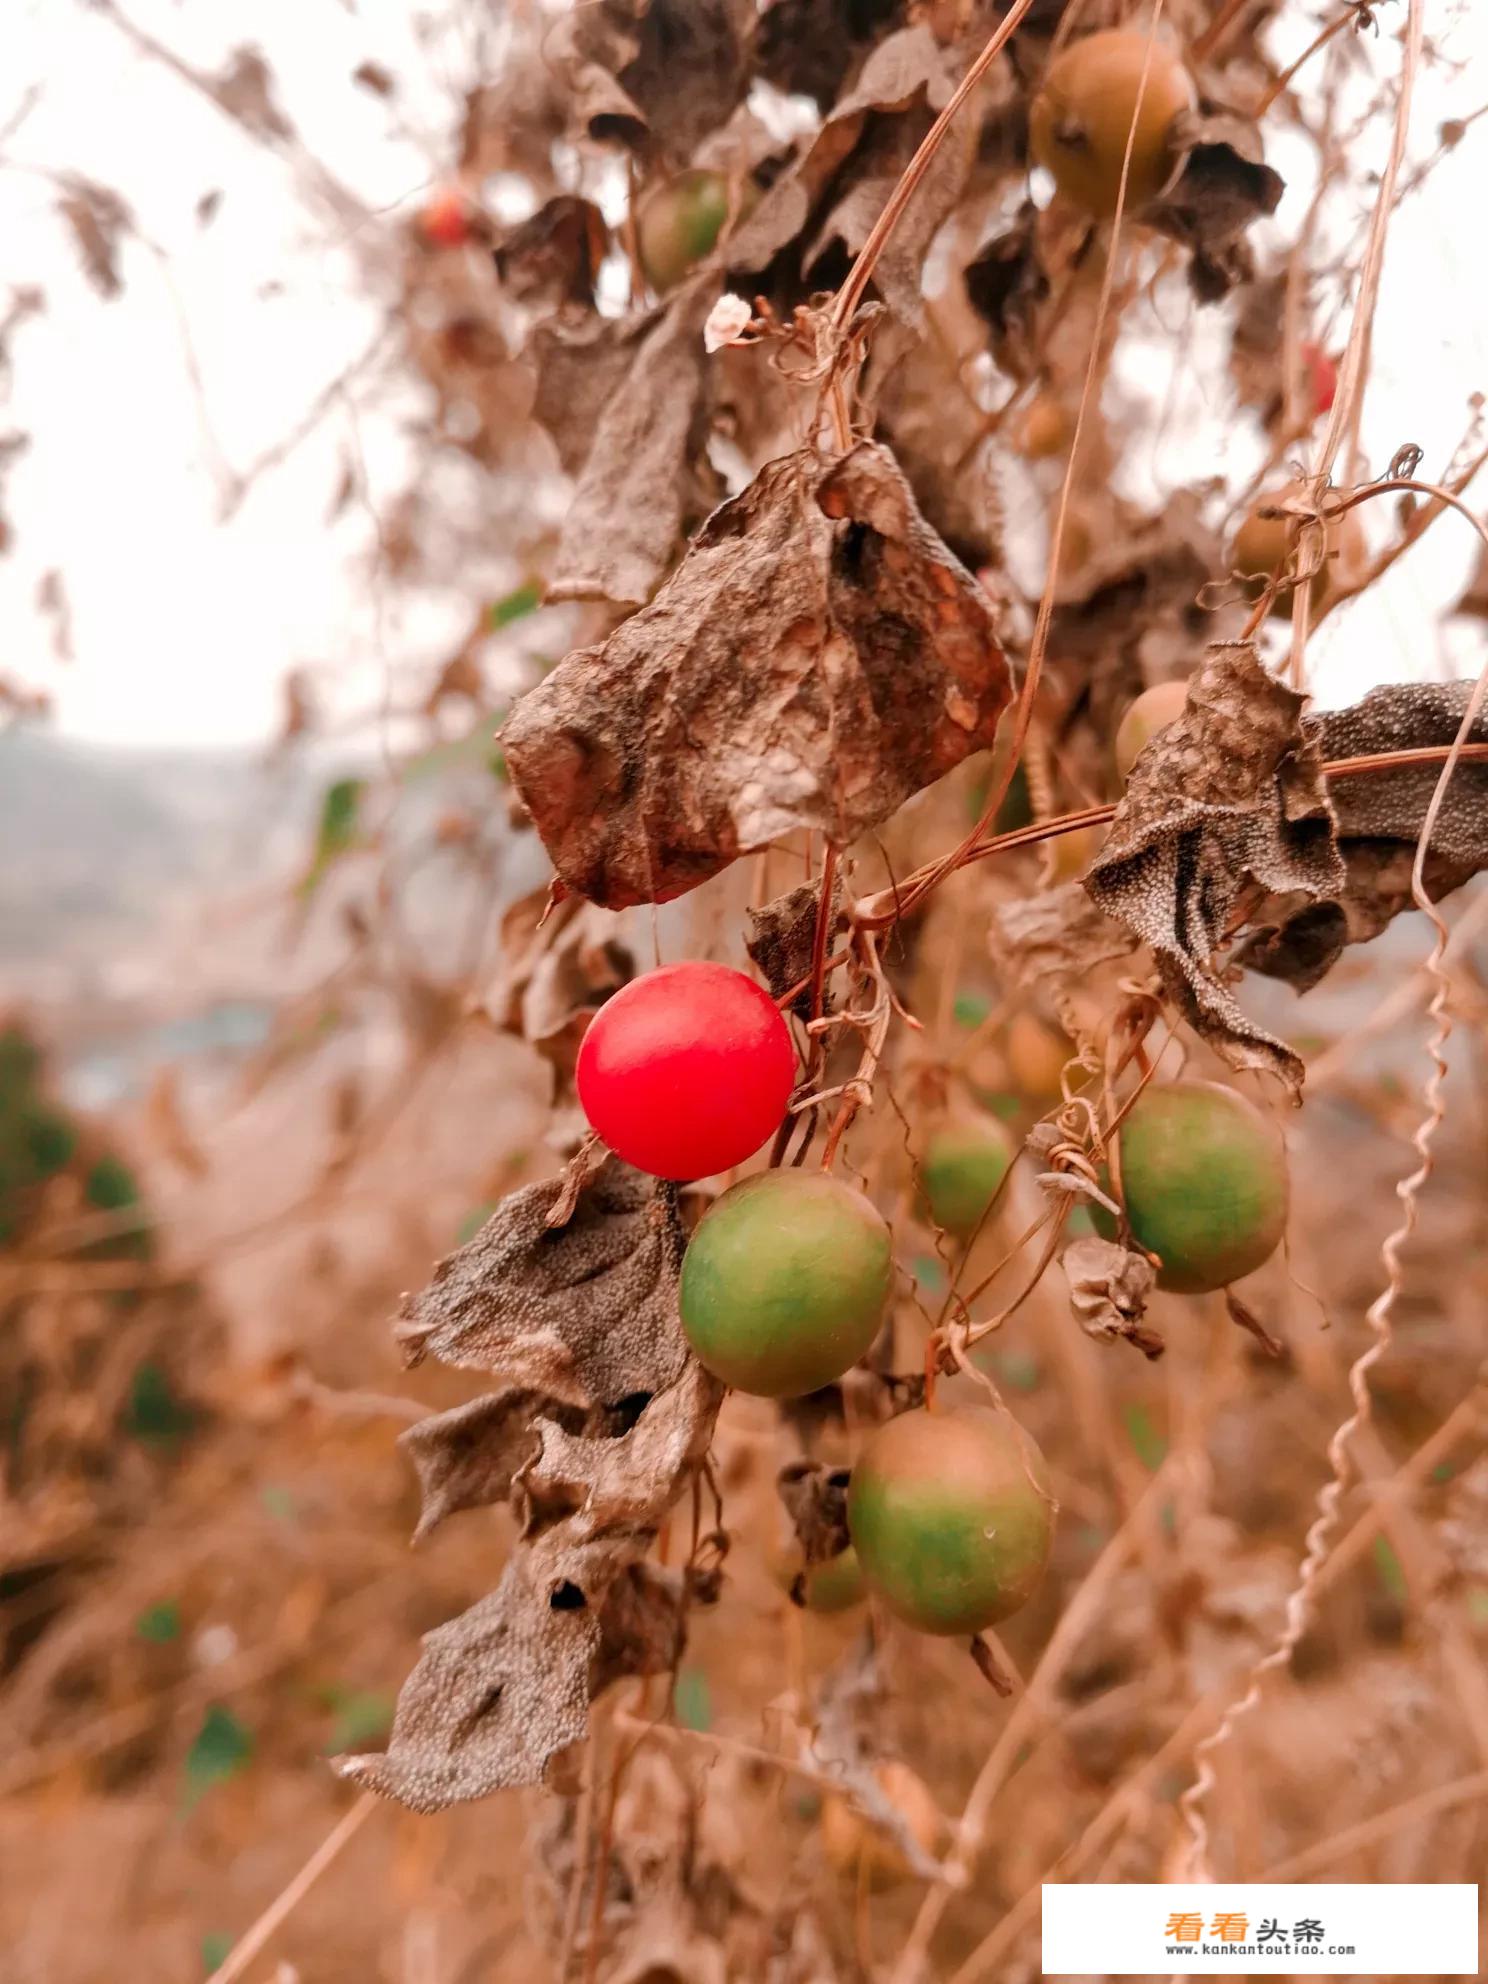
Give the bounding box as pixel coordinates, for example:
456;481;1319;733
502;442;1010;909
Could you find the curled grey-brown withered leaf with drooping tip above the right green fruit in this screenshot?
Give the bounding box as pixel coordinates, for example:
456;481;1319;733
1085;645;1343;1093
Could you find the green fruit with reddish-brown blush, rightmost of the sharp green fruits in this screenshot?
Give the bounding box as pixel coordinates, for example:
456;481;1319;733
1095;1081;1288;1296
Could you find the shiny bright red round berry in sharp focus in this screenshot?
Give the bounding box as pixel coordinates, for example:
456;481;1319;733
575;960;796;1178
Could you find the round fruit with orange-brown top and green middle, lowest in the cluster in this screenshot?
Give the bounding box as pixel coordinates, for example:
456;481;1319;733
847;1411;1055;1635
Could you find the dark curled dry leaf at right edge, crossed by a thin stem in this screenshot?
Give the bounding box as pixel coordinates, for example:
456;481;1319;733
1238;682;1488;992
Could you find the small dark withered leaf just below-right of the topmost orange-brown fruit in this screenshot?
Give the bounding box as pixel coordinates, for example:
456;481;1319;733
1143;103;1286;304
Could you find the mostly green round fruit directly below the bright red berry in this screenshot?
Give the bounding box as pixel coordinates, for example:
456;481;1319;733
681;1171;893;1399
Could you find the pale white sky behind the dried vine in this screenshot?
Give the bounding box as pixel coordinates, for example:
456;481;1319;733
0;0;1488;744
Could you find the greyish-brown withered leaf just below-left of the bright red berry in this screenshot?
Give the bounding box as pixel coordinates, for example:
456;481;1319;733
395;1159;686;1407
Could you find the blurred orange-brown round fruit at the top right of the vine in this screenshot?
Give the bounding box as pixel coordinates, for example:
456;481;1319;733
1028;28;1194;218
